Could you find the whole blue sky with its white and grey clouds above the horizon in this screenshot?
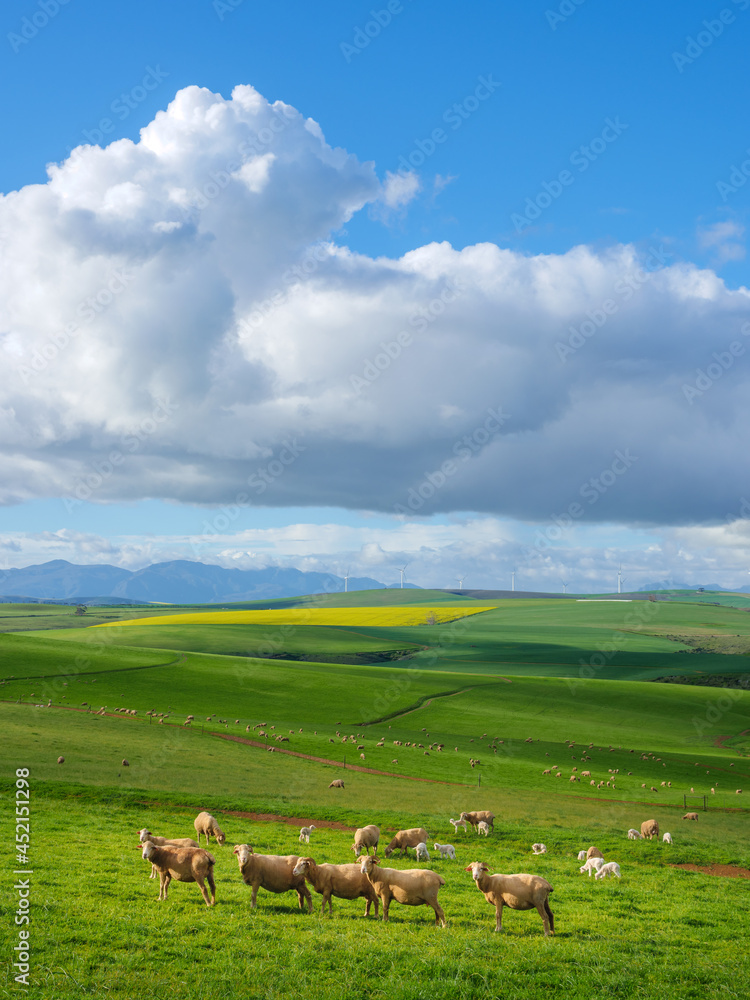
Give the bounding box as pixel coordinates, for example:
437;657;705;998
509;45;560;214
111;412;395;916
0;0;750;590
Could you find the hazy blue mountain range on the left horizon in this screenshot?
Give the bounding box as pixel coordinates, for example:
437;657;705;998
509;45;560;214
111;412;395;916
0;559;394;604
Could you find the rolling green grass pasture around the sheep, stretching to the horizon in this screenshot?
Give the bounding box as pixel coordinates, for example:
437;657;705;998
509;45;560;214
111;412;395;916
0;590;750;998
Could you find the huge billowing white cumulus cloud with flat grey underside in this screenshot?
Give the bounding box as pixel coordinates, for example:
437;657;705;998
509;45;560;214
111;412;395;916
0;86;750;524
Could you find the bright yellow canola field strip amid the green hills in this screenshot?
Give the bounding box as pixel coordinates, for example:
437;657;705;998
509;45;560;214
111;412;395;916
93;604;497;628
